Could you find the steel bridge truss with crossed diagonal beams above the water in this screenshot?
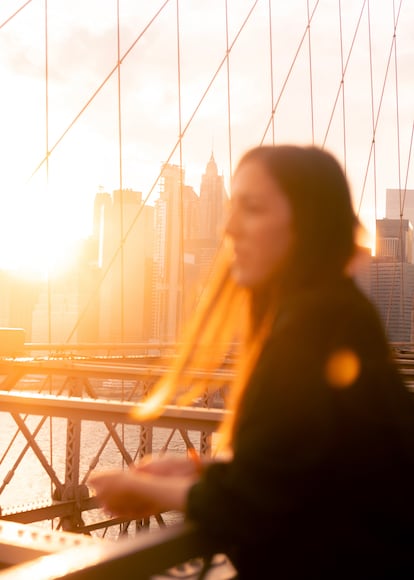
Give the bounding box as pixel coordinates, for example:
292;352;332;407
0;357;231;535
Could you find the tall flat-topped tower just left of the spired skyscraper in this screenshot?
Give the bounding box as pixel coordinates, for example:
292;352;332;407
152;164;185;342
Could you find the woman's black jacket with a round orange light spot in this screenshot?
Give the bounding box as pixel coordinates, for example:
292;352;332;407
187;279;414;580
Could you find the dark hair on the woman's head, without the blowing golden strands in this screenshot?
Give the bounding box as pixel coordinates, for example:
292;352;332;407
239;145;358;286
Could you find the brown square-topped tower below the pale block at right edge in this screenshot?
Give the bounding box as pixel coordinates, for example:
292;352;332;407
376;218;413;263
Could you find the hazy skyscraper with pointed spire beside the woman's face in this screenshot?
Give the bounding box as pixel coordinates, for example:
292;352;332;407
199;153;227;245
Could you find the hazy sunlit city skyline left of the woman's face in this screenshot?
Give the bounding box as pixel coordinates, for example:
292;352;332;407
0;154;227;343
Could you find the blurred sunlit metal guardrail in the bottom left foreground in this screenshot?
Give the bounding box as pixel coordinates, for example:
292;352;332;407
0;522;234;580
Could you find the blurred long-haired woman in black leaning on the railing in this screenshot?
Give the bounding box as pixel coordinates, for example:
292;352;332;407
92;145;414;580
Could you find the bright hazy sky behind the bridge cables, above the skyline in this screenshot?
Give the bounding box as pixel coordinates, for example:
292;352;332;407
0;0;414;274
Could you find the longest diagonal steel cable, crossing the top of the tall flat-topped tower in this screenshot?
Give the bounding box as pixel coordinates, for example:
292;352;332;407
62;0;259;342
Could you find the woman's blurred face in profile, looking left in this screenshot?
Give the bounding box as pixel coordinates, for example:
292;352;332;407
226;161;294;288
